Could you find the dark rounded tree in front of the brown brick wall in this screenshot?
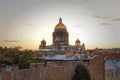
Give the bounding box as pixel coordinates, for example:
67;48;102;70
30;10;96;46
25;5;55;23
72;64;91;80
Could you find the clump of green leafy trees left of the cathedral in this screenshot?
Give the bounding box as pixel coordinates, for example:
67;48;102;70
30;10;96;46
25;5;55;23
2;49;32;69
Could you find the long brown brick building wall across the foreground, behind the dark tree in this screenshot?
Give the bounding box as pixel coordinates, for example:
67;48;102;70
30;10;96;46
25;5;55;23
0;57;104;80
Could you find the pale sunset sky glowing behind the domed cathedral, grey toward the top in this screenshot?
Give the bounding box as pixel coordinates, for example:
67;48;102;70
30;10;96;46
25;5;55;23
0;0;120;49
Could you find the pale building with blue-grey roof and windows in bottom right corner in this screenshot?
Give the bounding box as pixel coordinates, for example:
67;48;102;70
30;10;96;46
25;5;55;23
105;59;120;80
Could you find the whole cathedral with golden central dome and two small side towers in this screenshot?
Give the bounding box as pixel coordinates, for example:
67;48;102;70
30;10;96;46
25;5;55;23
39;18;85;54
